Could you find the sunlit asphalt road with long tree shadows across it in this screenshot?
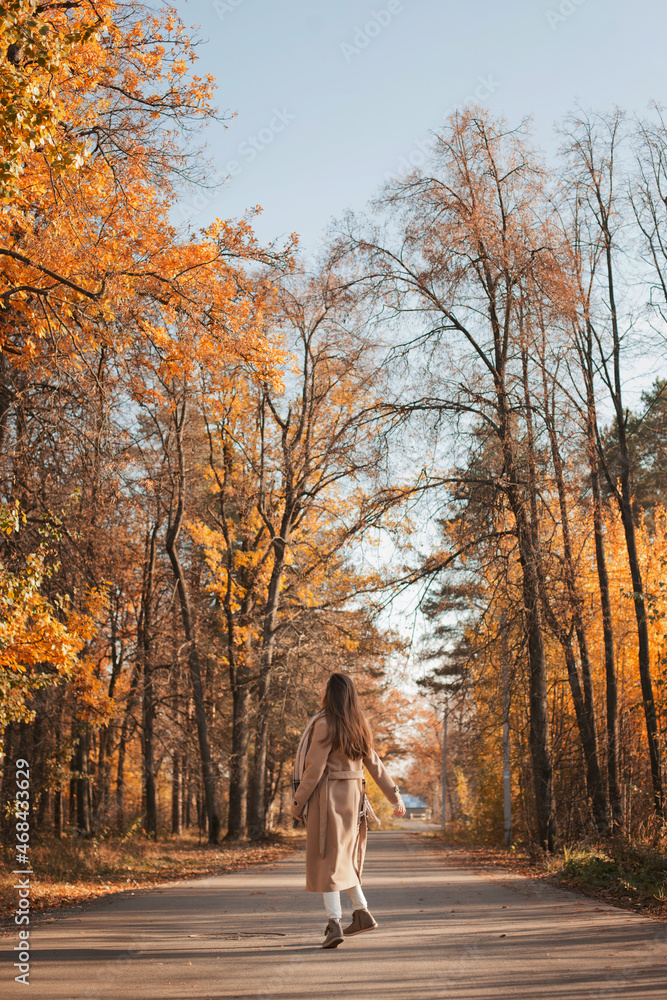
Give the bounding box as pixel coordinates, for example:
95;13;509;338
0;830;667;1000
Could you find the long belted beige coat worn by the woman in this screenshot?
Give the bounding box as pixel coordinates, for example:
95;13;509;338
292;718;400;892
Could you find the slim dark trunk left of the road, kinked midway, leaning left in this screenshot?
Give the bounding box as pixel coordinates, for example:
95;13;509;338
166;399;220;844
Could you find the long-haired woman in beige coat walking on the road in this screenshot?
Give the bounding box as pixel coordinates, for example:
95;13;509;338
292;673;405;948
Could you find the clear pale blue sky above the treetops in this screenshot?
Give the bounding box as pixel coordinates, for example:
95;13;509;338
176;0;667;253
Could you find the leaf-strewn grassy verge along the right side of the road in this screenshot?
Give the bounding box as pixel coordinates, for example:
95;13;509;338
432;831;667;920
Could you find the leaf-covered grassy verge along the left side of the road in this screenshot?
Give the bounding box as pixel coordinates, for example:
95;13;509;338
0;830;303;924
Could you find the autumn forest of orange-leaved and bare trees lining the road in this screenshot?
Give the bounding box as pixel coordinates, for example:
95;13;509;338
0;0;667;872
